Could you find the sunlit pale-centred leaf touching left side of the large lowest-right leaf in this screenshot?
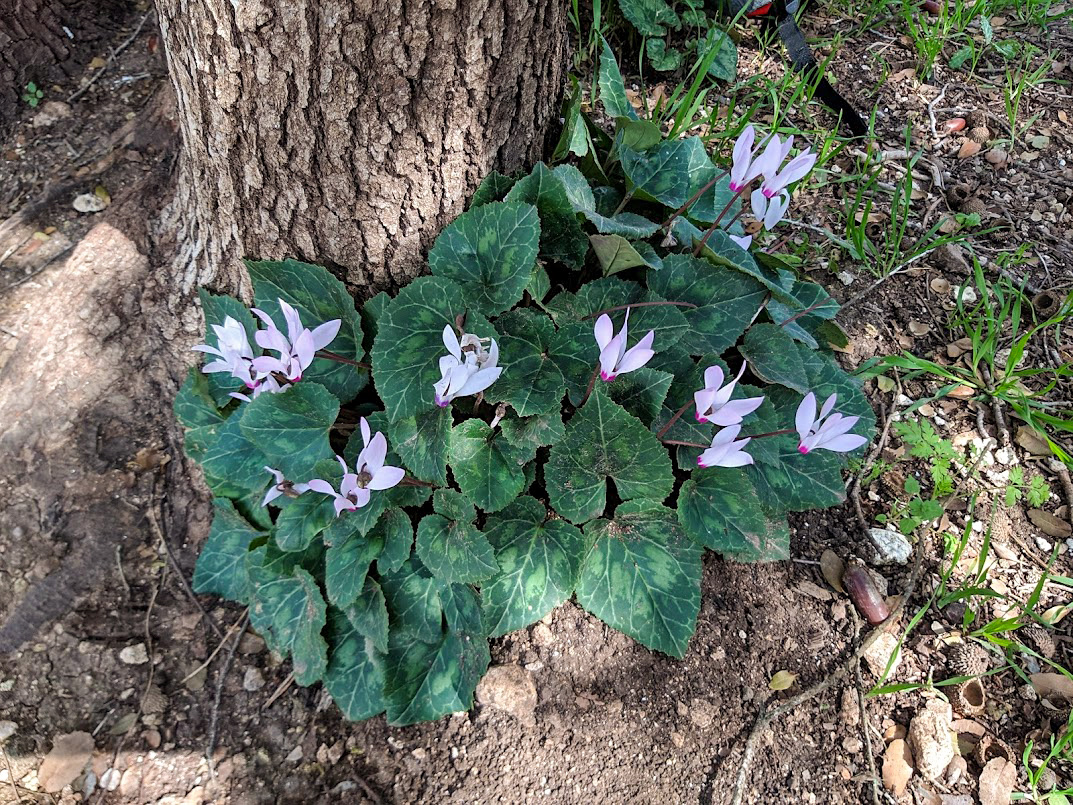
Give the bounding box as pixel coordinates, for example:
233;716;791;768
481;497;587;638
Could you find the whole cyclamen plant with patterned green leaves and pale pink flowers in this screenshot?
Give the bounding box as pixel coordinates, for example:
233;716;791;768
175;47;874;725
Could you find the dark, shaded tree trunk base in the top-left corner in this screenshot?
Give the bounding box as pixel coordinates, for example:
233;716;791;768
0;0;132;134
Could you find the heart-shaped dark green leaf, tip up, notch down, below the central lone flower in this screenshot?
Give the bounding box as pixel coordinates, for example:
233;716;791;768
544;386;674;523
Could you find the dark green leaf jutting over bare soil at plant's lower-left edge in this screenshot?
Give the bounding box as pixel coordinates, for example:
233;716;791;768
193;498;264;604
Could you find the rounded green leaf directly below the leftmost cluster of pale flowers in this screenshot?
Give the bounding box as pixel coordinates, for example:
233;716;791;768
240;380;339;481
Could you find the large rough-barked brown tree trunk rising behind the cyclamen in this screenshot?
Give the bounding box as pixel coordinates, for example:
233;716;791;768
158;0;567;297
